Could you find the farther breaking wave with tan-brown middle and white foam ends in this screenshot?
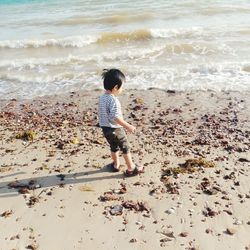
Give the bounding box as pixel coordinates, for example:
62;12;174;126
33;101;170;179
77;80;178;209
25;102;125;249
0;27;204;49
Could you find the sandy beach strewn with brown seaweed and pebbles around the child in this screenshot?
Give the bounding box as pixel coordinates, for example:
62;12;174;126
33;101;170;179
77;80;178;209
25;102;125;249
0;89;250;250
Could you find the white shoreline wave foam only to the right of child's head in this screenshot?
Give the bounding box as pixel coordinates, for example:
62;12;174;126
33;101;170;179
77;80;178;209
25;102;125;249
127;62;250;91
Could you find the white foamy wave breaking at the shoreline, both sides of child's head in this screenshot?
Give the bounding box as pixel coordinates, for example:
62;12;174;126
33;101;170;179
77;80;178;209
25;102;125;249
0;62;250;98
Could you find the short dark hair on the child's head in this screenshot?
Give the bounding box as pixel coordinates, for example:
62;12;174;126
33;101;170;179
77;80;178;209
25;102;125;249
102;69;125;90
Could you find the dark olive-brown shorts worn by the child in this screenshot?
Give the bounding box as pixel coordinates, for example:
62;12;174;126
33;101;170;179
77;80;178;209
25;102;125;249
102;127;130;154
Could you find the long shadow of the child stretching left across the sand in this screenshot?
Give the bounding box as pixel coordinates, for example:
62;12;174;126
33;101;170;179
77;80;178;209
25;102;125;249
0;164;124;198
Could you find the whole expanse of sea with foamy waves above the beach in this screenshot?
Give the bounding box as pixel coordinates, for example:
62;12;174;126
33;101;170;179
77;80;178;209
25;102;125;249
0;0;250;98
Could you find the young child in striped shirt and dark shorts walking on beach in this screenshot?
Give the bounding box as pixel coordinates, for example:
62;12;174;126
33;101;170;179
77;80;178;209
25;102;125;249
98;69;144;176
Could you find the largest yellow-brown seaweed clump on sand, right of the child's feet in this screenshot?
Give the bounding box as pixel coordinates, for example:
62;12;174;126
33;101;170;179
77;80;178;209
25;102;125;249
163;158;215;176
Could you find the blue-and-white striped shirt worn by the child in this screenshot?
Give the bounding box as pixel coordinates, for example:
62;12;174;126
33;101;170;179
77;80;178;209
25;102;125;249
98;93;123;128
